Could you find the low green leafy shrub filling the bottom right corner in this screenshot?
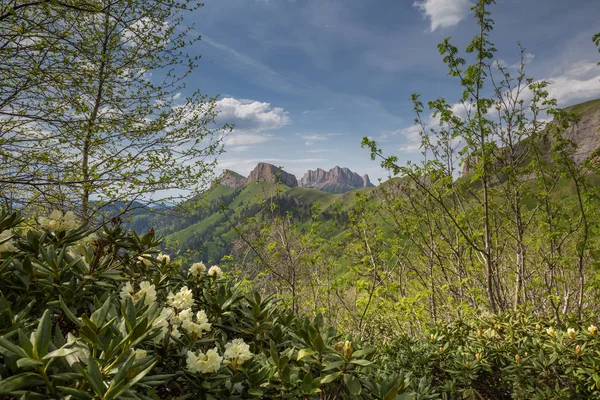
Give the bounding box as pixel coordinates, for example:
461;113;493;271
378;312;600;399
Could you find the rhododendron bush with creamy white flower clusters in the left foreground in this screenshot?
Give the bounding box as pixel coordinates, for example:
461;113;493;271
0;211;406;399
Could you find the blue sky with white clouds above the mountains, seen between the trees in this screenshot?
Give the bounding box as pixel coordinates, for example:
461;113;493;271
187;0;600;181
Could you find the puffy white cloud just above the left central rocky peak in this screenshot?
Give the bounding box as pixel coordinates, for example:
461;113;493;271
216;97;290;150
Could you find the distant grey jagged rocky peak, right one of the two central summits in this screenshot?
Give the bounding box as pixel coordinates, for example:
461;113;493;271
300;166;373;193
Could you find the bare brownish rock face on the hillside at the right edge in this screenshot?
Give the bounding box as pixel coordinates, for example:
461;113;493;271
563;110;600;164
